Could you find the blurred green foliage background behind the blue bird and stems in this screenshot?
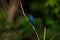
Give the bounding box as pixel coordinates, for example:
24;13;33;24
0;0;60;40
